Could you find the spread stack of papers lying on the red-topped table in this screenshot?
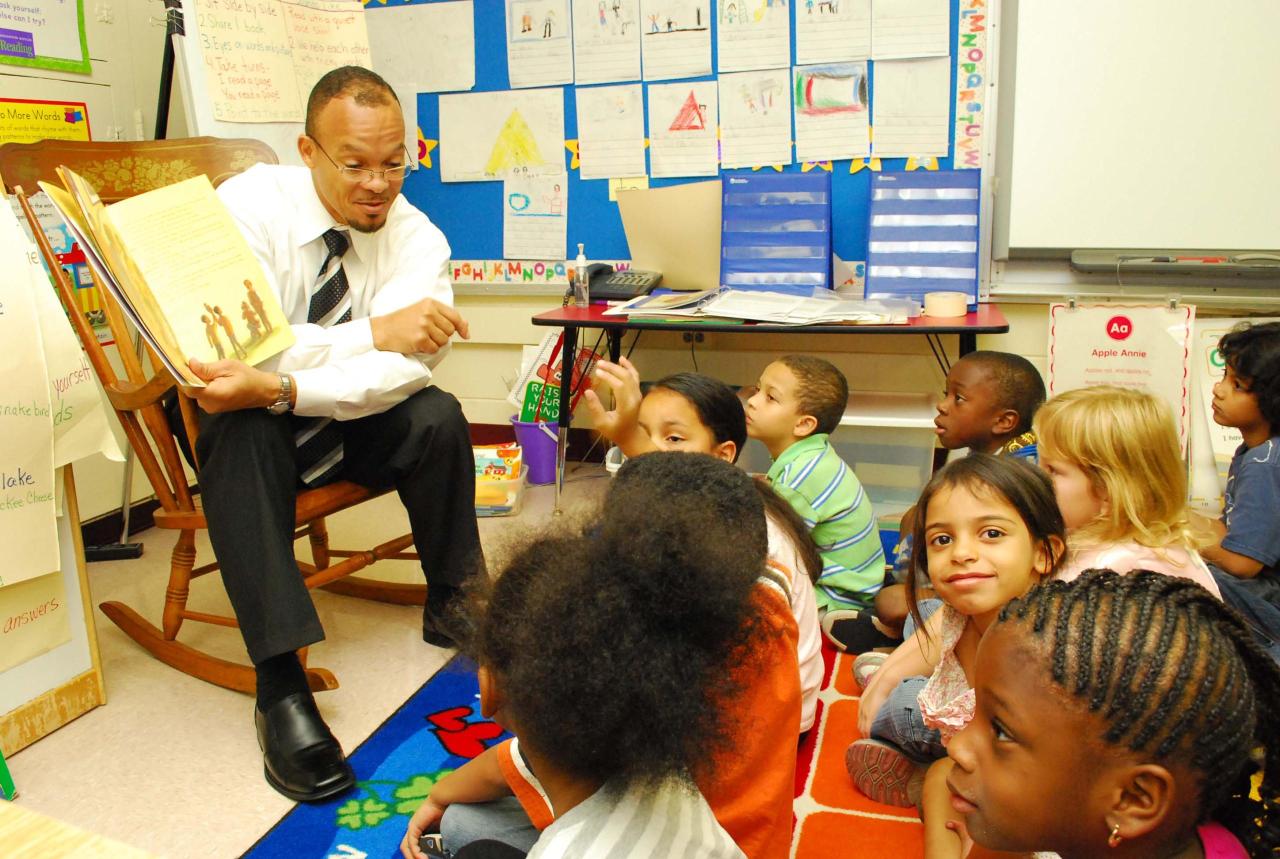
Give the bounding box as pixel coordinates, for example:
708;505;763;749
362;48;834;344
604;287;920;325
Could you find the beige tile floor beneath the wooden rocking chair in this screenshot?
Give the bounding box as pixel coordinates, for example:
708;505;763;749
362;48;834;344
0;463;607;858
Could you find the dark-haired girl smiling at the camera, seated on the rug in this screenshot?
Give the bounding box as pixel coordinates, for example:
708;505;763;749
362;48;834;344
845;453;1064;859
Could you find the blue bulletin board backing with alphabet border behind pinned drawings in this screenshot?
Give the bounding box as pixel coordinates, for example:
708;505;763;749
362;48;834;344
384;0;987;270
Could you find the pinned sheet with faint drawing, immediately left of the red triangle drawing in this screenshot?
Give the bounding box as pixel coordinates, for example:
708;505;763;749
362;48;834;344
576;83;645;179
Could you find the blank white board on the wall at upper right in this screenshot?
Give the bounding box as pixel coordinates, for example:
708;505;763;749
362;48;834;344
996;0;1280;253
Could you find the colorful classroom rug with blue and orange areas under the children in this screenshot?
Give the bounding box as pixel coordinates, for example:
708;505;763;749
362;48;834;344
244;650;924;859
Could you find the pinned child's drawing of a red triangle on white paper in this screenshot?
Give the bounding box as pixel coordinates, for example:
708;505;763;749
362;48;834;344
649;81;719;177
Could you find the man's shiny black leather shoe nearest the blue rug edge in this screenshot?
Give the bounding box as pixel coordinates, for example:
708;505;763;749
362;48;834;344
253;693;356;803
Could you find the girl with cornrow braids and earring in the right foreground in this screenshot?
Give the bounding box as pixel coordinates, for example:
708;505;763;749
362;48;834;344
947;570;1280;859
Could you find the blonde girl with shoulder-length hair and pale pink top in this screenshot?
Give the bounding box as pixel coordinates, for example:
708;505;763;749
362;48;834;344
1033;385;1221;598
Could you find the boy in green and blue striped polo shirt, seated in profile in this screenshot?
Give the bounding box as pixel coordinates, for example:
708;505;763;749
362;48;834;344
746;355;884;649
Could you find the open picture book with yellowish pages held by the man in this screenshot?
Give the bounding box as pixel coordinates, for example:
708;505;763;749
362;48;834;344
40;166;293;387
